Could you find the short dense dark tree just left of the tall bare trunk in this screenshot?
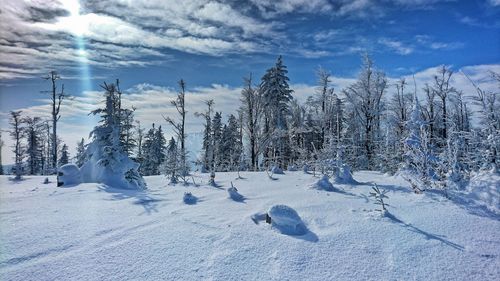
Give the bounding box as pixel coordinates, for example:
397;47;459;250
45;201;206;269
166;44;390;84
22;116;43;175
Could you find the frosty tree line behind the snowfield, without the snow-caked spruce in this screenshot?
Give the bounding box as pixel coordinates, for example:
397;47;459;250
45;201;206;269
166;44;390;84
4;56;500;191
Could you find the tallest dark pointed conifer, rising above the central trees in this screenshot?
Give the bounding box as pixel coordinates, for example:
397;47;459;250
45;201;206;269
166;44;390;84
259;56;293;168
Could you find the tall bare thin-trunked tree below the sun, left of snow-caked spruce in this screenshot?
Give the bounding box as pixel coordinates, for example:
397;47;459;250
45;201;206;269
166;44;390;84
44;71;69;169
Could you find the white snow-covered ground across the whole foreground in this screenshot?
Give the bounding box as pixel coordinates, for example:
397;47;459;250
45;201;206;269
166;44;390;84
0;171;500;280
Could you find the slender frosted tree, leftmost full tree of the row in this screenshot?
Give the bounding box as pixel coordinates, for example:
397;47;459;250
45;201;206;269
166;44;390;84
9;111;26;180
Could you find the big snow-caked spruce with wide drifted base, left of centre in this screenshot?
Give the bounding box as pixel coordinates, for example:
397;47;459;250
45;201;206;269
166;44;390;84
81;83;146;189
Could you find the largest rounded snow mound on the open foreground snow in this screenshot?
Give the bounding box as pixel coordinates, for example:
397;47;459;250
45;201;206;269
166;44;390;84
267;205;307;235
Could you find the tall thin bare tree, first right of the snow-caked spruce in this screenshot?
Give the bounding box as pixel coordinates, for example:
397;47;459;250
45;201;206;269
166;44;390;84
163;79;189;177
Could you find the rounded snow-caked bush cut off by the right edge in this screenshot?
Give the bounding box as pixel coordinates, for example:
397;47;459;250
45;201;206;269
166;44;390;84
466;172;500;214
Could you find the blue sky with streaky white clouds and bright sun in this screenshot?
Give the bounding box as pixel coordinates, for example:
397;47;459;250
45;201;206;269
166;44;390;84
0;0;500;162
